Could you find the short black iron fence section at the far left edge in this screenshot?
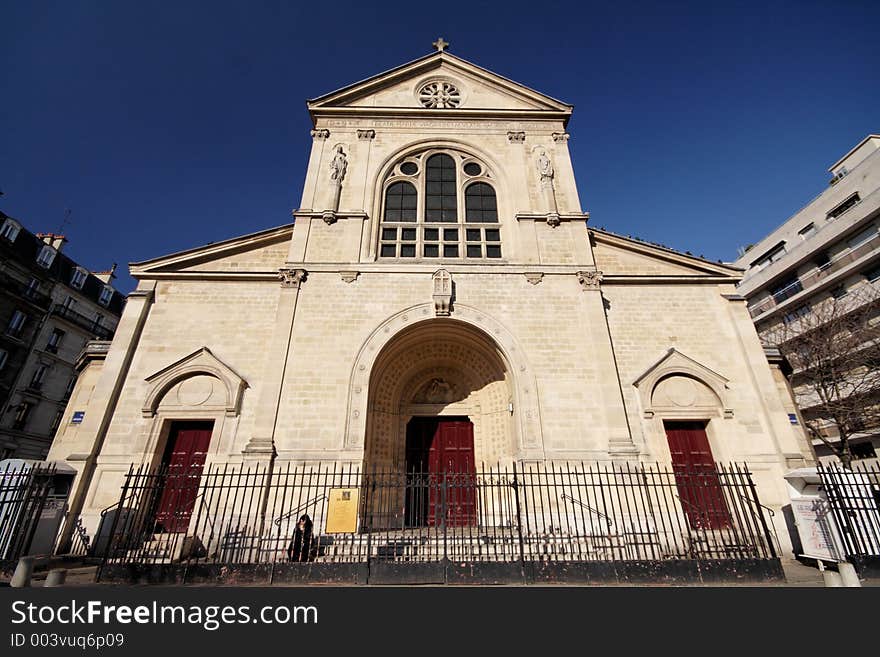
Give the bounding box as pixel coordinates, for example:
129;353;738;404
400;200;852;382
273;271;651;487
0;463;55;570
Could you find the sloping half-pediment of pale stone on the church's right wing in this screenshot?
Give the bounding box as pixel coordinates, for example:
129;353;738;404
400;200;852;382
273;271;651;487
590;229;742;281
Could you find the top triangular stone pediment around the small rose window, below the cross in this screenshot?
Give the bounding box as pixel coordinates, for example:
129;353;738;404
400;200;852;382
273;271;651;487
309;52;572;114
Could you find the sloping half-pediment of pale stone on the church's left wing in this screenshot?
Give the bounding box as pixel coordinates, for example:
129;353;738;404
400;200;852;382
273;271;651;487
129;224;293;278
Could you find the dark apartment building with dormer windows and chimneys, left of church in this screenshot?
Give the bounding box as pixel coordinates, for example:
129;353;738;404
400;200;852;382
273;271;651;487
0;212;124;459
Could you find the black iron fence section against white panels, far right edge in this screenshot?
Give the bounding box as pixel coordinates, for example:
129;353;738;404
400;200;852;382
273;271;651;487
817;463;880;560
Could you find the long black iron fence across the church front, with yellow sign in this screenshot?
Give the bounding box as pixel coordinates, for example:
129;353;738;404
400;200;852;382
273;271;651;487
98;464;778;580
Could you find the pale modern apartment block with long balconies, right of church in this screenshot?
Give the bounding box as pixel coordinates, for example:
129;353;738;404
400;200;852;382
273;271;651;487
735;134;880;461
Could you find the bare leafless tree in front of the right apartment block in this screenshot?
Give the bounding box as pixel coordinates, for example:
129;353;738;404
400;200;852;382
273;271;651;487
762;283;880;468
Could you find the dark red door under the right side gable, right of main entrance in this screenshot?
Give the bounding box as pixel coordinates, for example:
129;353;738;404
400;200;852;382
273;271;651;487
664;422;730;529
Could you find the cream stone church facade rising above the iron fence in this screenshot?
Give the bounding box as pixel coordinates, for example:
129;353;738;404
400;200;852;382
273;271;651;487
50;42;812;572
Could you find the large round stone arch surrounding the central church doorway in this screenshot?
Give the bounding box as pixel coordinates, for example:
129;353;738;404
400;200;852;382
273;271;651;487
345;304;543;466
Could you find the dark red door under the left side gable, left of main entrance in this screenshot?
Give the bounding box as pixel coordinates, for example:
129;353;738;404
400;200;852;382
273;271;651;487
156;422;214;532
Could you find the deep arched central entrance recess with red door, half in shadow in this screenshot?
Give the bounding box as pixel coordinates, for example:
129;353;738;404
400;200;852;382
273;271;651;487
364;318;516;473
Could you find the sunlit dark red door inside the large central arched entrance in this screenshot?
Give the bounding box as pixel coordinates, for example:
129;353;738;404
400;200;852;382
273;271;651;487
428;419;477;527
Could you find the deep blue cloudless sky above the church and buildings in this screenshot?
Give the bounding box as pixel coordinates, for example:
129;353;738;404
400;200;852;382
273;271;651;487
0;0;880;292
